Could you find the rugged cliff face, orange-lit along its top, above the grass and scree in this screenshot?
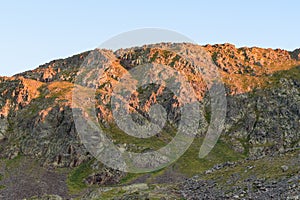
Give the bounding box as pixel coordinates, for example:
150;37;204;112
0;44;300;199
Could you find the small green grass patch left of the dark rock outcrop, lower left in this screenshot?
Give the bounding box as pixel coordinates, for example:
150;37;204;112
67;160;93;194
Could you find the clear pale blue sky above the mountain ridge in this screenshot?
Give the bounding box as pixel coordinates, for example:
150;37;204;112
0;0;300;75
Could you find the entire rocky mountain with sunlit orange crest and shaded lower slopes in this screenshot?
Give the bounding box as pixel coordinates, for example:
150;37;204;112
0;43;300;199
